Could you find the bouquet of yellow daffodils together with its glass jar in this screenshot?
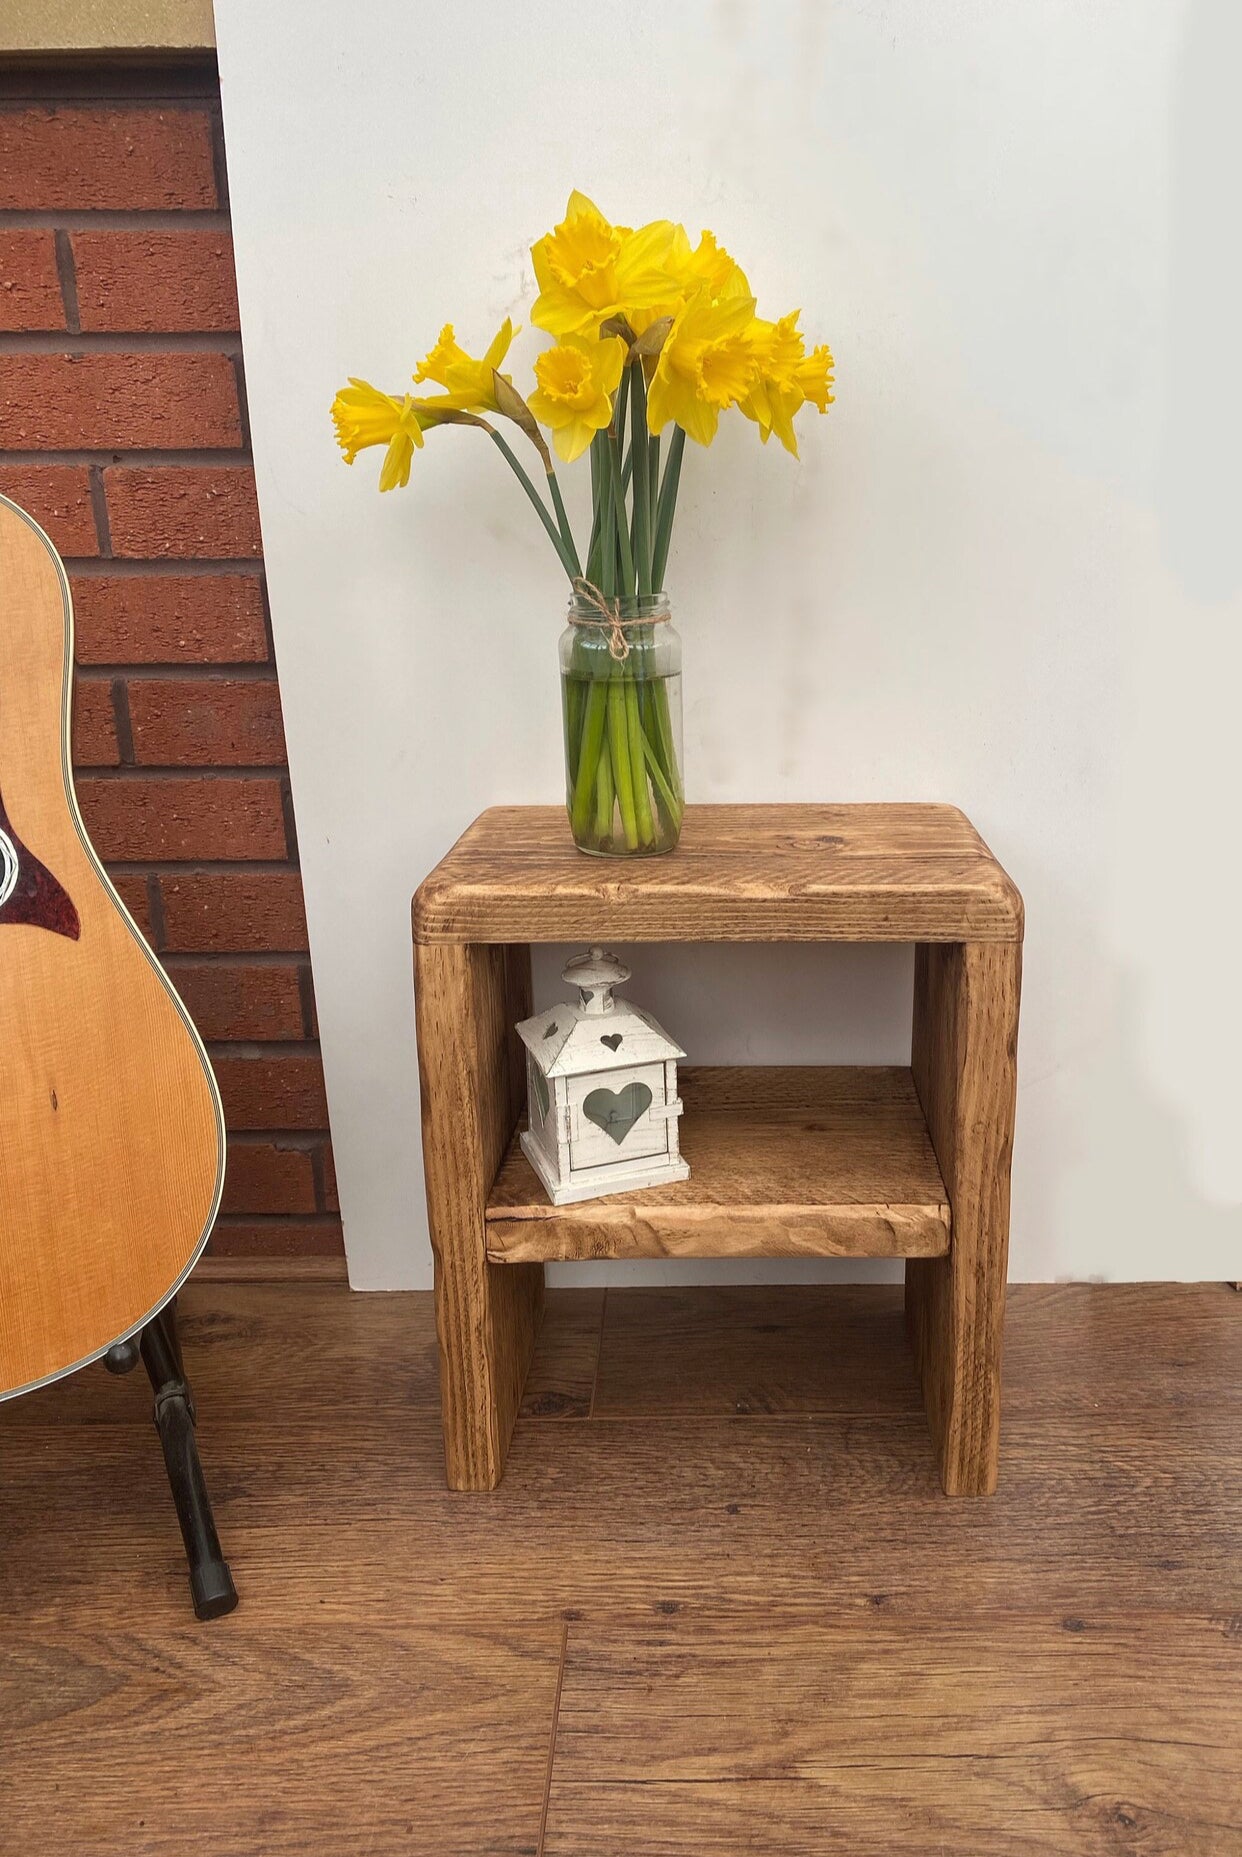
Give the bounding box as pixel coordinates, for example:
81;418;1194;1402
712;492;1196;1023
332;193;832;854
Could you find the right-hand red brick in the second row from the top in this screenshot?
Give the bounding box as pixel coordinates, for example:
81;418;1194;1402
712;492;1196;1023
71;230;238;334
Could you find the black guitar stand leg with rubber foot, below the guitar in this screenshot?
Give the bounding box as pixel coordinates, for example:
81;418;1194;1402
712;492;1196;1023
104;1298;238;1619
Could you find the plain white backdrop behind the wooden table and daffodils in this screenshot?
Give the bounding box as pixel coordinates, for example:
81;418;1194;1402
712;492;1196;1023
215;0;1242;1287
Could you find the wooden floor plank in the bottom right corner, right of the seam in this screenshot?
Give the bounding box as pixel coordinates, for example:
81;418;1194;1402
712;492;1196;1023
544;1612;1242;1857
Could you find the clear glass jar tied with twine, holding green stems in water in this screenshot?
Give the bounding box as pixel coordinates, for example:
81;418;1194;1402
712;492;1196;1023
561;592;685;858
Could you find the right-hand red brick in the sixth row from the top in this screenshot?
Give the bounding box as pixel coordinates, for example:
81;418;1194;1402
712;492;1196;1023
130;678;284;767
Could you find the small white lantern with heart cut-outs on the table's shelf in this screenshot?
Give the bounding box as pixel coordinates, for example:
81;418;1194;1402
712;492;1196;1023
518;947;691;1205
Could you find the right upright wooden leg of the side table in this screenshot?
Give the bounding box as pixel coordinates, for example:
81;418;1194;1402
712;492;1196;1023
906;941;1021;1497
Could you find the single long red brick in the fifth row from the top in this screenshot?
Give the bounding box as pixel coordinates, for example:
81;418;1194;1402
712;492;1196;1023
69;579;267;665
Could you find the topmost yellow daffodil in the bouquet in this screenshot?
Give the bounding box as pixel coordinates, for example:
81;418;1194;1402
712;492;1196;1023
531;191;674;338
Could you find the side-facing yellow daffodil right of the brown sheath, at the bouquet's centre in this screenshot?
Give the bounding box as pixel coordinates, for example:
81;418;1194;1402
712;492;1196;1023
646;288;756;446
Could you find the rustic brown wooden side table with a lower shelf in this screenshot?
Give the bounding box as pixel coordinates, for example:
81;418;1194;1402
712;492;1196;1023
414;806;1023;1495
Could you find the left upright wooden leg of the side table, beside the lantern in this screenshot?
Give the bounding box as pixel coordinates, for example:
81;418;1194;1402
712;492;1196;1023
414;943;544;1489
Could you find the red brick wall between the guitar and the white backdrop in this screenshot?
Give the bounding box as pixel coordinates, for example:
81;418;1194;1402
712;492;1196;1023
0;67;342;1255
